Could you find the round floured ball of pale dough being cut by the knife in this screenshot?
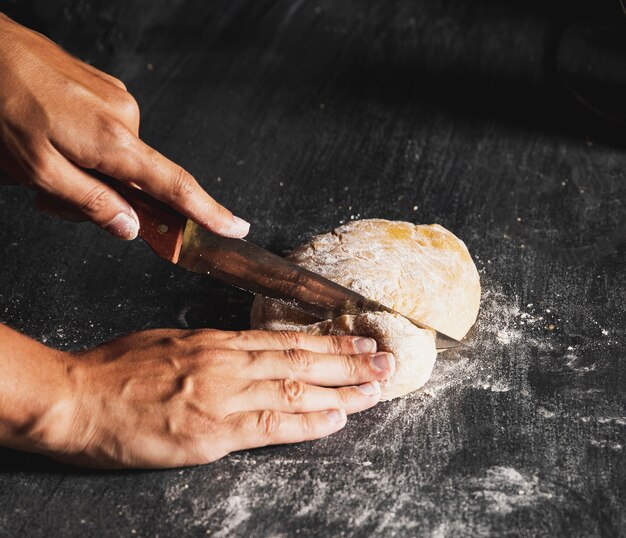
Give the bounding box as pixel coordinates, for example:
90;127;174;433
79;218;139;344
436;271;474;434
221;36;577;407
251;219;480;400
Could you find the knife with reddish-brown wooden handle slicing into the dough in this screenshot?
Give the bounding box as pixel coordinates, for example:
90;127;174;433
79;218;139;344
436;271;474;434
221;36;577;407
114;183;463;350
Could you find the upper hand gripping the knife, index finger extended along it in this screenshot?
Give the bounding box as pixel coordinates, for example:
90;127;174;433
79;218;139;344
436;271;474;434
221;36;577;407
0;14;249;239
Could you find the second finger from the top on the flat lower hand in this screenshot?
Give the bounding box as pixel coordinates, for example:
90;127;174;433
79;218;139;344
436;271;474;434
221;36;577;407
240;349;396;387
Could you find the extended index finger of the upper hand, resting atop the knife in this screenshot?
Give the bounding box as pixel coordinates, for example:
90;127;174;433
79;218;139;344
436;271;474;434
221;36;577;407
88;127;250;237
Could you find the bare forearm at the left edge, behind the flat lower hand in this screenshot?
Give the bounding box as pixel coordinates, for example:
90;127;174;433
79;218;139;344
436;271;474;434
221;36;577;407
0;324;72;453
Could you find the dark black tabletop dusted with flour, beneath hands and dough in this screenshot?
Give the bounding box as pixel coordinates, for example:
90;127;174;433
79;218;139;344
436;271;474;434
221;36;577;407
0;0;626;537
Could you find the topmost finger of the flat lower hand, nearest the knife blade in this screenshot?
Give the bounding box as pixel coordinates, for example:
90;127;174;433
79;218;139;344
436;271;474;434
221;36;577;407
188;329;376;355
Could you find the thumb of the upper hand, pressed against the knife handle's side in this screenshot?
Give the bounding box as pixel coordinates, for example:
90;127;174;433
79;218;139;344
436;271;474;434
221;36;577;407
34;155;139;239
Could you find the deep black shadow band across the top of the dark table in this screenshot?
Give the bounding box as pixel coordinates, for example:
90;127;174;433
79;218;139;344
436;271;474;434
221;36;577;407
7;0;626;147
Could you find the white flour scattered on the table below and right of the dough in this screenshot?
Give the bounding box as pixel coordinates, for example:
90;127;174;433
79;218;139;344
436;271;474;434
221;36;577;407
157;266;626;538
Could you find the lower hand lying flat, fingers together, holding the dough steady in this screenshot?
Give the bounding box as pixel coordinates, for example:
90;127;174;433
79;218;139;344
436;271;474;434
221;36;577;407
54;324;395;468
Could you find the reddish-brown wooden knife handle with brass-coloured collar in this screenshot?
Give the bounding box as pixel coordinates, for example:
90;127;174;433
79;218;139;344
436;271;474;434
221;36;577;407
109;181;187;263
